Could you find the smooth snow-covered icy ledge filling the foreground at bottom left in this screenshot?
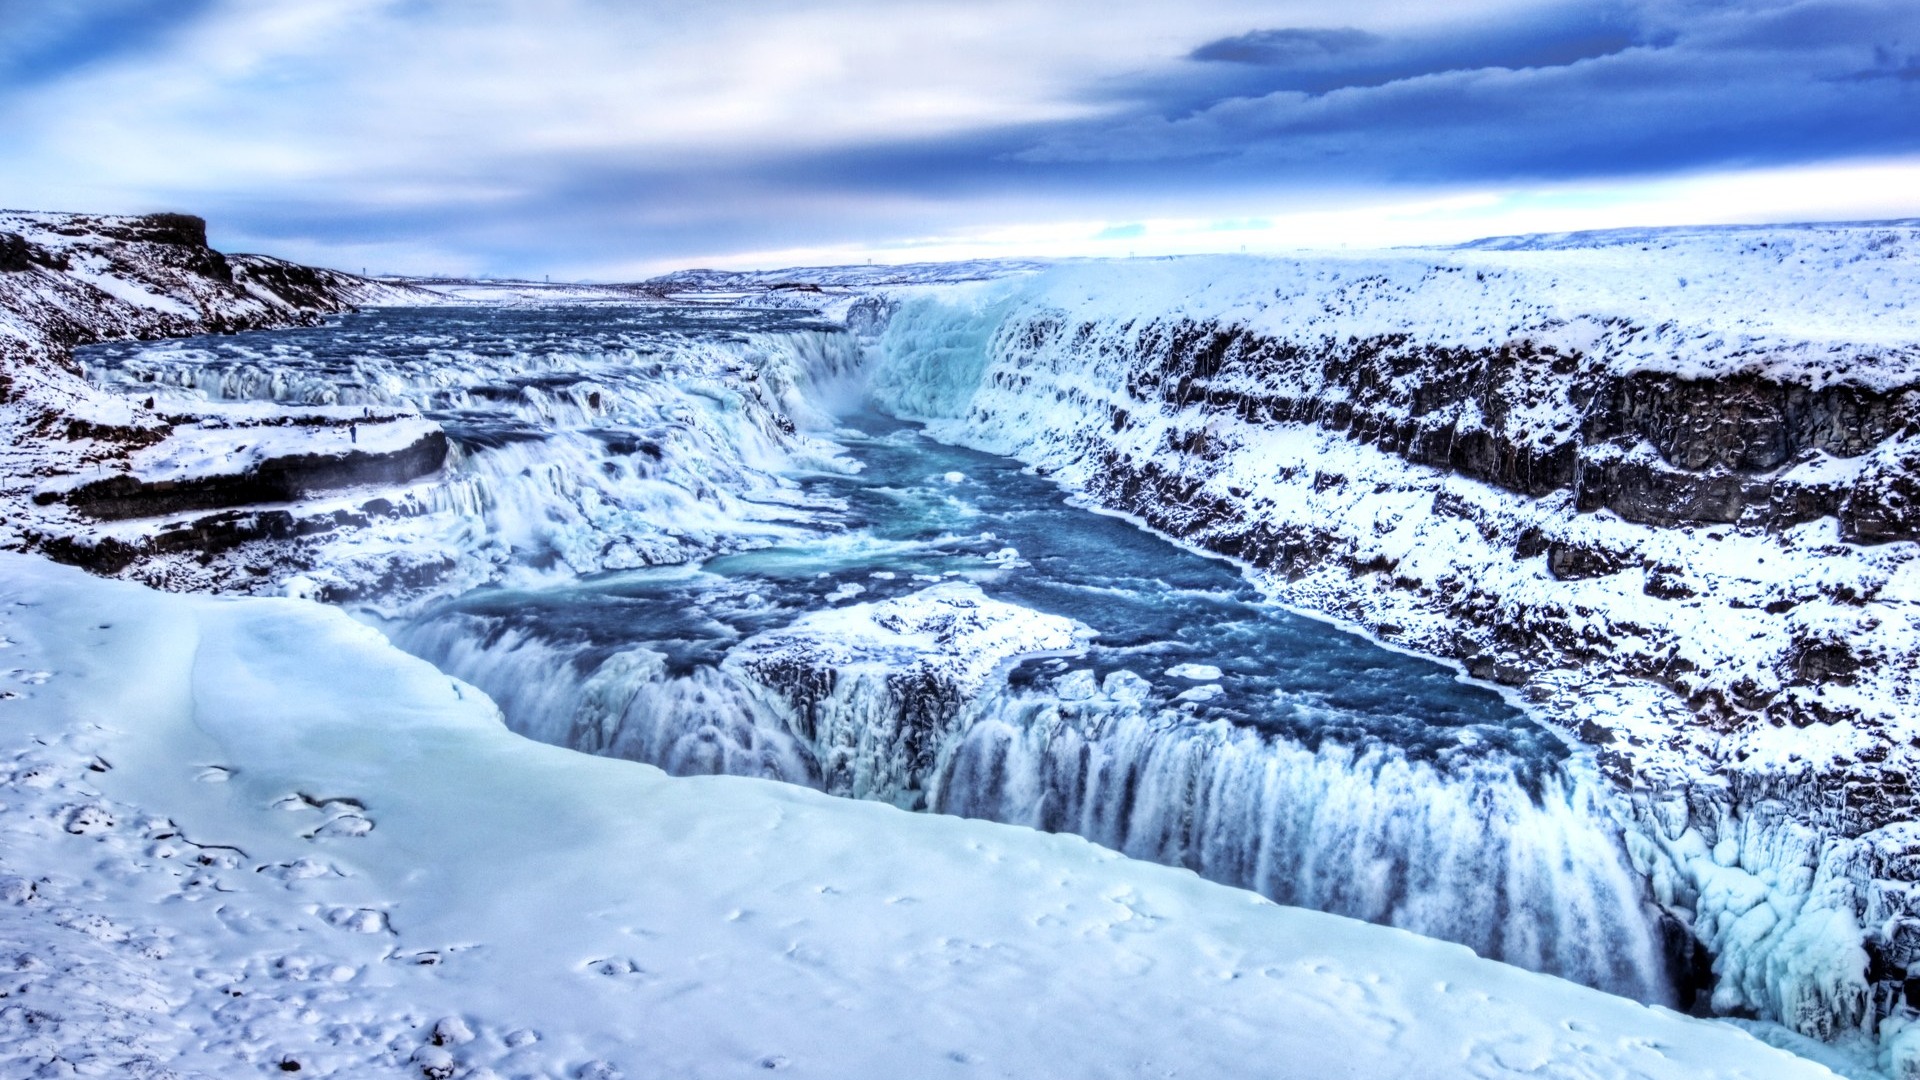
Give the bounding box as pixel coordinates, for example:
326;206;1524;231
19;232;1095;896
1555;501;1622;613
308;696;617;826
0;555;1830;1078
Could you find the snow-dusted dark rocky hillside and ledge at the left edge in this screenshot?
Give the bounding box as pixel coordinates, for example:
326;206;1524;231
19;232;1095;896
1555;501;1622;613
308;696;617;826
0;211;447;588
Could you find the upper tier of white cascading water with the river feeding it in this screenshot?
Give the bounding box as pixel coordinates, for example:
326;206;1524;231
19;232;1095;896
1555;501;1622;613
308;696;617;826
81;306;862;586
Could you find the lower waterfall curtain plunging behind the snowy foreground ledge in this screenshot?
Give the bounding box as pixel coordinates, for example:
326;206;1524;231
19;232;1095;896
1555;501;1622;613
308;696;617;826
394;613;1672;1003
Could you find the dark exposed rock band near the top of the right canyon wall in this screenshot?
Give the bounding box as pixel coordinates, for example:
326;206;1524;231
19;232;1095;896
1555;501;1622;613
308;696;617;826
1002;317;1920;542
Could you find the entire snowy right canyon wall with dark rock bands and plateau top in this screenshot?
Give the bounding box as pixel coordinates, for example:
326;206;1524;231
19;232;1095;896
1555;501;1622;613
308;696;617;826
864;225;1920;1053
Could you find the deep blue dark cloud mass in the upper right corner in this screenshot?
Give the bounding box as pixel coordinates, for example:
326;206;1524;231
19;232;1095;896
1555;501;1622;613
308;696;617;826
1016;0;1920;181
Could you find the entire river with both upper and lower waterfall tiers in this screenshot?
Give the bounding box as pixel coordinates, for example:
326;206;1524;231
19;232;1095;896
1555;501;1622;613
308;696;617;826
86;299;1670;1001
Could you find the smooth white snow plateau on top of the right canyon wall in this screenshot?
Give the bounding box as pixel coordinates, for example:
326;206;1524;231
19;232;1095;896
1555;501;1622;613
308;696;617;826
867;223;1920;386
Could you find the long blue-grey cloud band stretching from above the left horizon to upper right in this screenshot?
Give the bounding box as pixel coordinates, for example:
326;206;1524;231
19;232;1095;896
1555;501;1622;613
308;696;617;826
202;4;1920;269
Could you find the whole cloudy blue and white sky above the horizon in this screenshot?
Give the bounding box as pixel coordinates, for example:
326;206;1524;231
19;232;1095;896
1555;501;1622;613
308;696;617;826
0;0;1920;281
